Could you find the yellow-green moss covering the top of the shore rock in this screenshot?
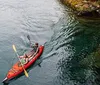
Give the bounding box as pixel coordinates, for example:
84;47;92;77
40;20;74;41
63;0;100;12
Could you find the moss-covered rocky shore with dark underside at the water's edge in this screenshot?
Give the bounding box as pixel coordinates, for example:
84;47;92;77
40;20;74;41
60;0;100;17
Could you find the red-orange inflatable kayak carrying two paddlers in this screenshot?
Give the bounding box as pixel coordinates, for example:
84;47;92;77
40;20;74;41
3;45;44;83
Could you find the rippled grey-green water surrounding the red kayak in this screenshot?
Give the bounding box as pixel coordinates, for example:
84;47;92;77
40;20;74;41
0;0;100;85
